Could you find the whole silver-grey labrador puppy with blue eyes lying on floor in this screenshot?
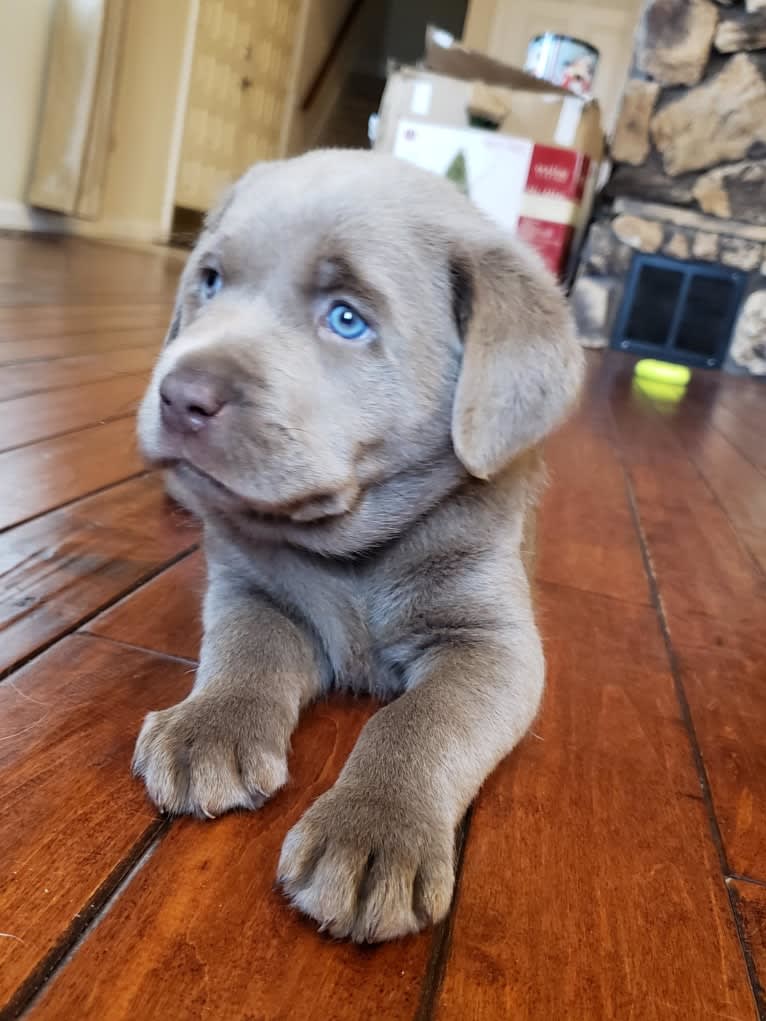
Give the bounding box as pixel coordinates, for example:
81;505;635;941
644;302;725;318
135;151;582;941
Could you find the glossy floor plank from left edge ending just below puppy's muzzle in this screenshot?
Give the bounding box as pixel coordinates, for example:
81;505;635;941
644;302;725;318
0;476;199;682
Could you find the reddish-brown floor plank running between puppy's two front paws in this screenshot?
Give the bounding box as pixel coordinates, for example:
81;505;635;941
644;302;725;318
28;698;432;1021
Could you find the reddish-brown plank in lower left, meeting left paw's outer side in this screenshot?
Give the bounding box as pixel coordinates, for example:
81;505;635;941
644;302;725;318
0;637;195;1016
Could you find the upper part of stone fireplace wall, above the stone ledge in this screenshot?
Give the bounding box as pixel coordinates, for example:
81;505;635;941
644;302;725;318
607;0;766;225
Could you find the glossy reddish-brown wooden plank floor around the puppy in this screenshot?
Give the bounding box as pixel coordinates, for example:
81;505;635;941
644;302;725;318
0;233;766;1021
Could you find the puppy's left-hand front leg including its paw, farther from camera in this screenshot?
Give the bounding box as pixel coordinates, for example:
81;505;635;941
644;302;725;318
133;575;320;818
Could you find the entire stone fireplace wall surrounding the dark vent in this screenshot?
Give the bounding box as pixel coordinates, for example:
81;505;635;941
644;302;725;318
572;0;766;379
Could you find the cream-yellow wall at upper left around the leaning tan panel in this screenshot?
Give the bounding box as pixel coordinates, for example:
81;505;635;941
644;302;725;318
0;0;197;241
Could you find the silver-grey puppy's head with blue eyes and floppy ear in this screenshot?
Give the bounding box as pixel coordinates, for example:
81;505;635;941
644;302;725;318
139;151;581;555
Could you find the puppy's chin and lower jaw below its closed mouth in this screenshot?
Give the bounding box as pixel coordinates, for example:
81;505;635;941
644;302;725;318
162;460;357;529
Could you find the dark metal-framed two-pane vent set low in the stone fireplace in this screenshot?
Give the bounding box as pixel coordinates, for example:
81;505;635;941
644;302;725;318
612;253;747;368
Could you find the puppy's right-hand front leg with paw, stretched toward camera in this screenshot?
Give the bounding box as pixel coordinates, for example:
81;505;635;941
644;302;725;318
279;607;544;942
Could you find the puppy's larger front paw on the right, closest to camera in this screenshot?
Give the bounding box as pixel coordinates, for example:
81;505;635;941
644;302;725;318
279;787;454;943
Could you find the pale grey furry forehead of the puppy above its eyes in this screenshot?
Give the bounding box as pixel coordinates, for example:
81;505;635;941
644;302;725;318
211;152;462;293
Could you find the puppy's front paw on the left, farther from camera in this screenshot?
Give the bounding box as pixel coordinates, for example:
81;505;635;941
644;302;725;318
133;692;287;819
